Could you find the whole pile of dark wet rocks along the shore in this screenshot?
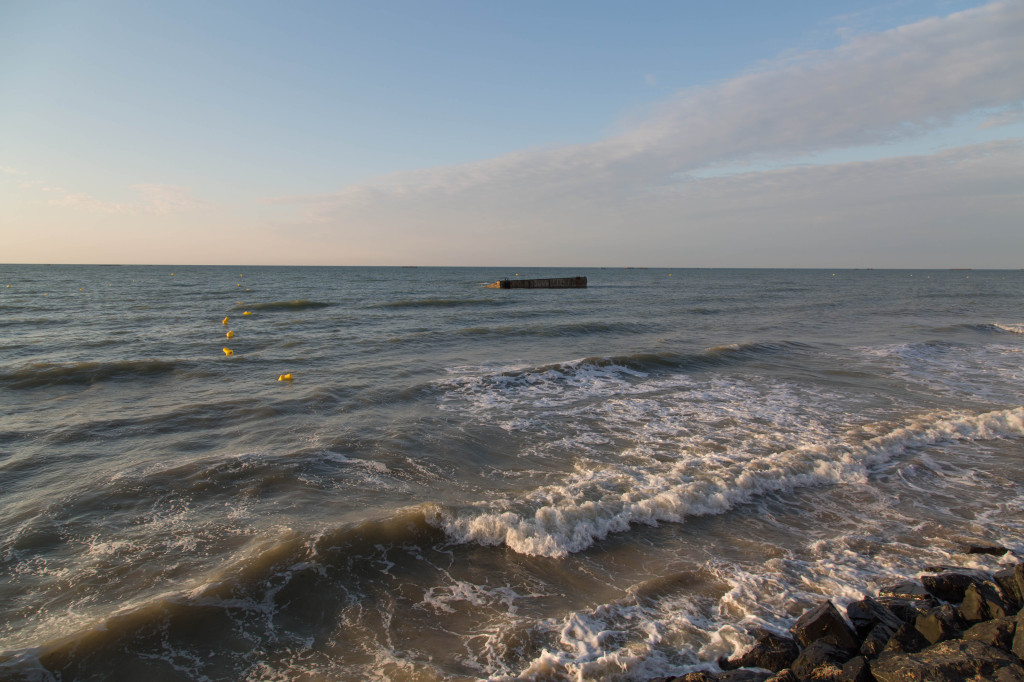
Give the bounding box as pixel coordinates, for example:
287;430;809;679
650;545;1024;682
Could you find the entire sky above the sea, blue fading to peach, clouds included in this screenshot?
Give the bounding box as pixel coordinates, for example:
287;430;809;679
0;0;1024;269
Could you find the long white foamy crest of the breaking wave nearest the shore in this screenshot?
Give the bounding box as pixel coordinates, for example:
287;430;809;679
428;408;1024;557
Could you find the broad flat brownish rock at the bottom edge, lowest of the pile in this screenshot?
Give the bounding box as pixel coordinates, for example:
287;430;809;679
871;639;1024;682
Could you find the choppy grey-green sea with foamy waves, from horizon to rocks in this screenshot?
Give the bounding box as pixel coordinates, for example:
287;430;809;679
0;265;1024;680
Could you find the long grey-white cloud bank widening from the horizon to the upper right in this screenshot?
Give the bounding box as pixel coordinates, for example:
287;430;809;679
268;2;1024;264
